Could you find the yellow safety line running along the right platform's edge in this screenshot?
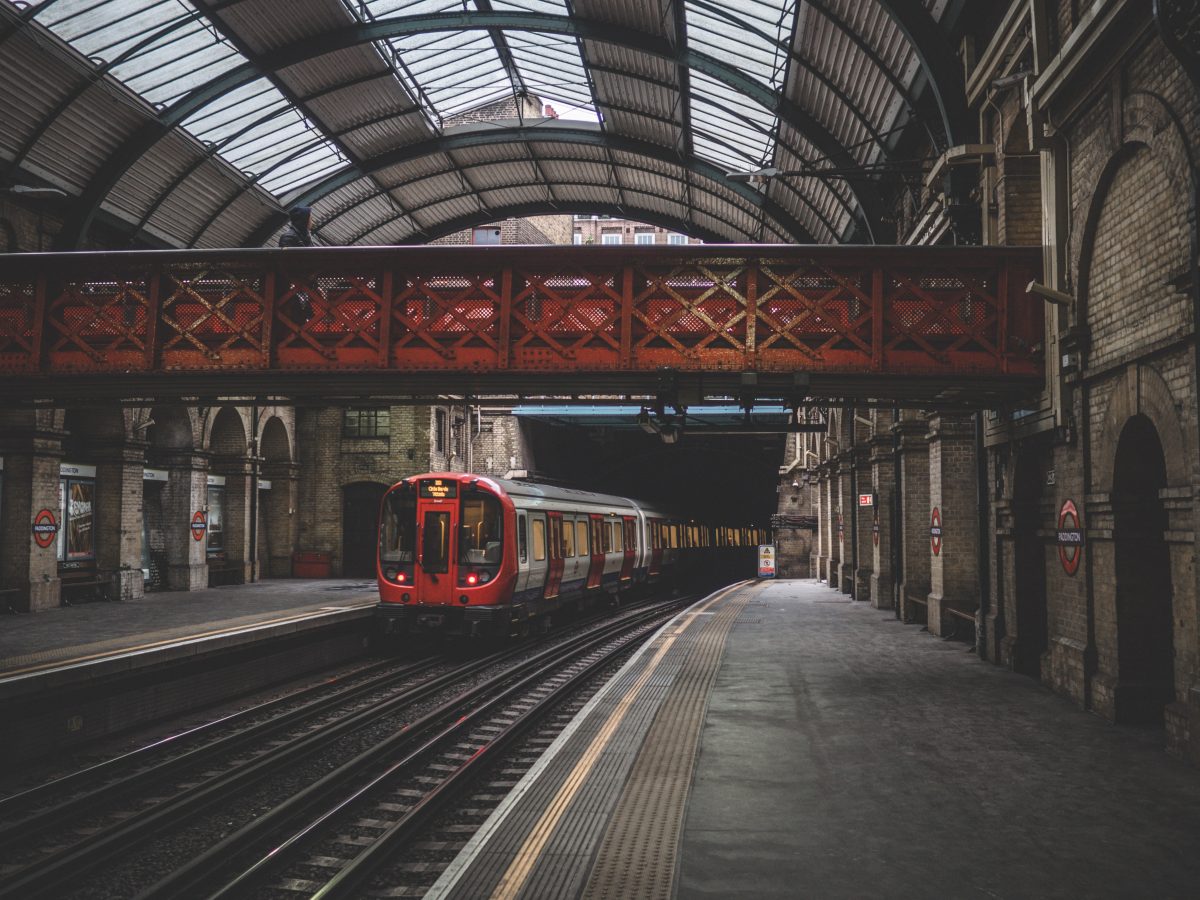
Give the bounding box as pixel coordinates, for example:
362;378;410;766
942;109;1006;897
492;584;744;900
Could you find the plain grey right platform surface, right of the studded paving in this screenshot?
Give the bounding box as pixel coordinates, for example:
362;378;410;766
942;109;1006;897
674;581;1200;899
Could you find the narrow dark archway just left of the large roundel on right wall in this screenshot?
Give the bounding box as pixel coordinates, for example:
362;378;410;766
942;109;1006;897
1013;452;1049;678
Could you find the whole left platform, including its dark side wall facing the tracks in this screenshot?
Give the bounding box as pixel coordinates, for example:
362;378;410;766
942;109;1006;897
0;578;379;760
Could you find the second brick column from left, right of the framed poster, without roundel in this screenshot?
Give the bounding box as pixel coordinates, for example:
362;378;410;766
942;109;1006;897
94;440;146;600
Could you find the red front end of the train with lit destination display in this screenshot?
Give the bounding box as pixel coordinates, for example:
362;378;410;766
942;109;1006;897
378;473;517;635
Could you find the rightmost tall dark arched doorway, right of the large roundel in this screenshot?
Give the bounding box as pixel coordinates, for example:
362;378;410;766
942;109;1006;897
1112;415;1175;725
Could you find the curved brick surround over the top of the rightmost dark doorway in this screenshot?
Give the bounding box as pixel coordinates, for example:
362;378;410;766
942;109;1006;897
1092;365;1196;492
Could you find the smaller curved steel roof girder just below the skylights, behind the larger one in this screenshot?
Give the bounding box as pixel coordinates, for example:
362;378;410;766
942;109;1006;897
246;122;815;246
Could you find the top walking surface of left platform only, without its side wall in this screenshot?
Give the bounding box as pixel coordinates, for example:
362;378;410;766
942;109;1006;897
0;578;379;678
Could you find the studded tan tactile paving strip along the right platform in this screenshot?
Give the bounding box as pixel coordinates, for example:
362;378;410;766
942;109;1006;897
582;590;752;900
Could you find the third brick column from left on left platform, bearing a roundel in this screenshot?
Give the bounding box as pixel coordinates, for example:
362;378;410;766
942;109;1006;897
162;452;209;590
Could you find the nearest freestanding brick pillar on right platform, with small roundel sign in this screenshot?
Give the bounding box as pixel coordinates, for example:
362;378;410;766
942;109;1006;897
928;415;979;635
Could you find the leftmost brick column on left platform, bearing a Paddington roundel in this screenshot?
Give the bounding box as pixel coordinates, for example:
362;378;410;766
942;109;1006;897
0;428;64;612
